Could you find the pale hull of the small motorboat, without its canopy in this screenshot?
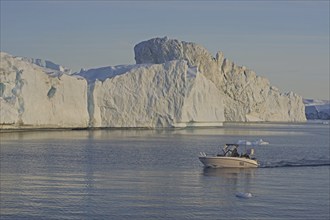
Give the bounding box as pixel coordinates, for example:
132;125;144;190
199;156;259;168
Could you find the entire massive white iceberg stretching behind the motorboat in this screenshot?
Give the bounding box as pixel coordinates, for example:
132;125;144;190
0;38;306;128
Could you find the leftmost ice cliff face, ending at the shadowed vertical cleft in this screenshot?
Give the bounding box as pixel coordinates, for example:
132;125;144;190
0;52;89;128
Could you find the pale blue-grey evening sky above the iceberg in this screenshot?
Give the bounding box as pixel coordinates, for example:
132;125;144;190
1;0;329;99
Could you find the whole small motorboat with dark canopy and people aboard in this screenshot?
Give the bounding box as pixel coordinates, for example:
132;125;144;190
198;144;259;168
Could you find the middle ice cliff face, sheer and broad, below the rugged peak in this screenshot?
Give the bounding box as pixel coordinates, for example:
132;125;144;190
79;61;224;127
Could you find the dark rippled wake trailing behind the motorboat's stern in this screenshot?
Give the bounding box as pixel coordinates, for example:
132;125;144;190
260;159;330;168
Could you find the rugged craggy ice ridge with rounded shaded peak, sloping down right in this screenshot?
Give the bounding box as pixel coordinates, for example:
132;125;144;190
134;37;306;121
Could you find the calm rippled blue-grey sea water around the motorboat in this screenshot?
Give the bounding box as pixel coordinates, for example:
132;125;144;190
0;123;330;219
